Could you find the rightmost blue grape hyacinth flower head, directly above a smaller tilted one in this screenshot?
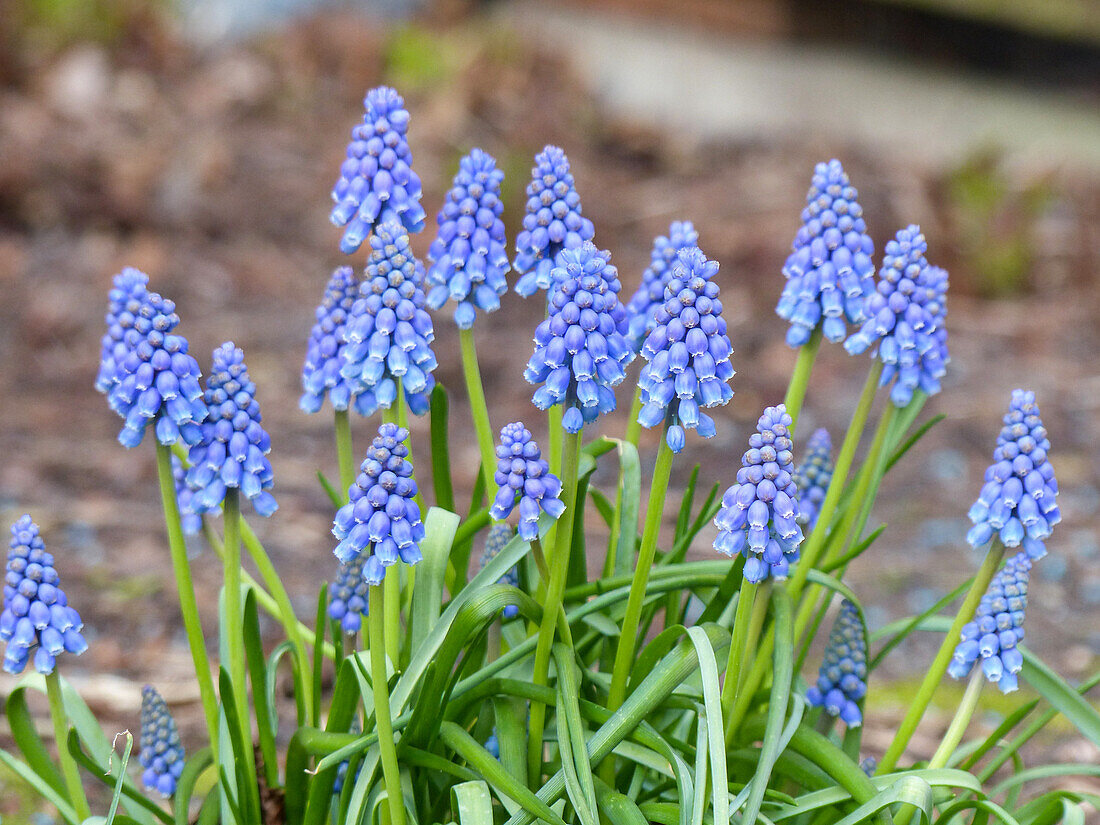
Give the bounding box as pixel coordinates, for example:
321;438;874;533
966;389;1062;559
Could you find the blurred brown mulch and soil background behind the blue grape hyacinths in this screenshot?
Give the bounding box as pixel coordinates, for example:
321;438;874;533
0;0;1100;817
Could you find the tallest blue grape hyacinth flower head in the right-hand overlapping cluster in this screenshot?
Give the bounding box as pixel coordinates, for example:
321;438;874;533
776;161;875;347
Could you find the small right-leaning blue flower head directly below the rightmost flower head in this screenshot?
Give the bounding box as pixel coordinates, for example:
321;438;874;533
947;551;1032;693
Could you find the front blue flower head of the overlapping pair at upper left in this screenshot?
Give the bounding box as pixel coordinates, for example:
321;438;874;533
107;290;207;447
